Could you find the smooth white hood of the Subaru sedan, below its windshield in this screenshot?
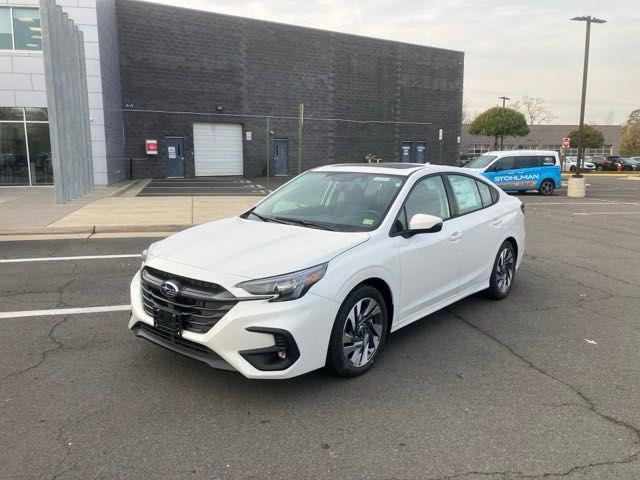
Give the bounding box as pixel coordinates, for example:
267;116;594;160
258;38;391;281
149;217;369;279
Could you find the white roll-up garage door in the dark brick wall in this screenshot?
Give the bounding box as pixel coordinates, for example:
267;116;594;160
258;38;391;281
193;123;242;176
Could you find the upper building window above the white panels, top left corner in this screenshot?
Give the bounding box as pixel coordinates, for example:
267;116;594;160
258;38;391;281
0;7;42;50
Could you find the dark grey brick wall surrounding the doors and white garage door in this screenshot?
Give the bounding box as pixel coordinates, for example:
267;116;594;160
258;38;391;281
116;0;464;177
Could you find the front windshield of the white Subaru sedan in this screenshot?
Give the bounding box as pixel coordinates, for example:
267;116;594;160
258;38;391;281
245;171;405;232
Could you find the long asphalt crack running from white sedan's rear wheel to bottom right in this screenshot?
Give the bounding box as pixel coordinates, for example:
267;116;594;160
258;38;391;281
442;308;640;480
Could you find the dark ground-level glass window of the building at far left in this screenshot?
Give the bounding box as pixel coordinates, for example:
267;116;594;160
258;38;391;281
0;107;53;185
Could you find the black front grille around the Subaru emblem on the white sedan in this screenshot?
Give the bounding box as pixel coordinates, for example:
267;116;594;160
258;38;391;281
141;267;238;333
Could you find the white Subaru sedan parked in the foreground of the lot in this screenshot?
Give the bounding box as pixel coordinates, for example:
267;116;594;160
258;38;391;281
129;163;525;379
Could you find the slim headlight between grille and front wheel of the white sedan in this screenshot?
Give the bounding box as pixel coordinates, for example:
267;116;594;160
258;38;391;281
236;263;327;302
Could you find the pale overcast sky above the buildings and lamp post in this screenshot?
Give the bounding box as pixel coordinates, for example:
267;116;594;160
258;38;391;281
151;0;640;124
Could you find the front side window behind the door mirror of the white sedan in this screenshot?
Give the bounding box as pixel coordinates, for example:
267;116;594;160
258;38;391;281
396;175;451;231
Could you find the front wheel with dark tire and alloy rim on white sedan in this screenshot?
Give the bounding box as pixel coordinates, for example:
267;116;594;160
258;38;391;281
327;285;389;377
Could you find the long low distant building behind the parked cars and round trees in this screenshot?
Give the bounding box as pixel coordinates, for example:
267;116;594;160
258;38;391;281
460;125;622;157
